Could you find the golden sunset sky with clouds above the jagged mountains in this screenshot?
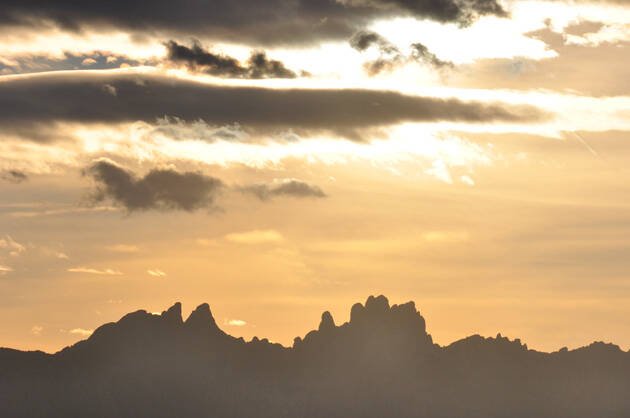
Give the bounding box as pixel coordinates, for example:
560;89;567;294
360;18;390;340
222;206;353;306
0;0;630;352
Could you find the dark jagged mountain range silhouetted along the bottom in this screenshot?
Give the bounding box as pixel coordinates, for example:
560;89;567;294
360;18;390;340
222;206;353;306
0;296;630;418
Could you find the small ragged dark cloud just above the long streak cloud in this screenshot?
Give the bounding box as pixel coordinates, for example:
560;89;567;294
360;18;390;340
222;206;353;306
166;41;297;79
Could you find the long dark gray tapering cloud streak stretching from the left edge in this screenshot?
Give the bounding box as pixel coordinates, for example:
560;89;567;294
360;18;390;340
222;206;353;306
0;71;550;140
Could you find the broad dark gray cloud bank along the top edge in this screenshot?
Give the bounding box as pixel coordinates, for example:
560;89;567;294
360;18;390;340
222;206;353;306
0;0;507;44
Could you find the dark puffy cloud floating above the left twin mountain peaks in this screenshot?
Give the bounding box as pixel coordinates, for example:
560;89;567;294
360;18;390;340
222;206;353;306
84;159;223;212
